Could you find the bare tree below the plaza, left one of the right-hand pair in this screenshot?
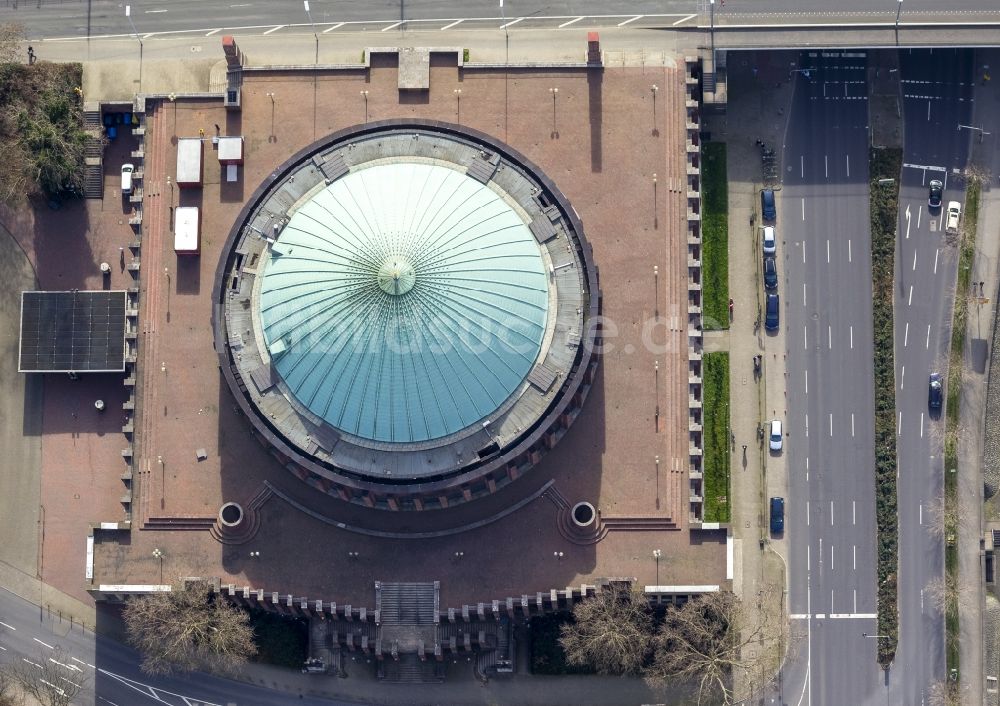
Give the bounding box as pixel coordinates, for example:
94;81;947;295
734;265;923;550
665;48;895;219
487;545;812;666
559;583;653;674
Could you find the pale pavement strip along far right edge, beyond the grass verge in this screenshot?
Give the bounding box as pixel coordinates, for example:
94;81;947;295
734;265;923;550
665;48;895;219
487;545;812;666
945;44;1000;706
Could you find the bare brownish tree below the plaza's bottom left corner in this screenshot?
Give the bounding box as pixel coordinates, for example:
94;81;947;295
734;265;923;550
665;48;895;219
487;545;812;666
122;581;257;674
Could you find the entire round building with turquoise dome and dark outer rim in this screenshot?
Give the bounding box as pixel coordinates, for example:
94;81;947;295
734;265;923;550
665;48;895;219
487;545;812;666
213;121;599;510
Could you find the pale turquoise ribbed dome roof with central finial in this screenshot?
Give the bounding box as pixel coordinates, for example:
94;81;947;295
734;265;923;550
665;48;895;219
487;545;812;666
260;161;549;443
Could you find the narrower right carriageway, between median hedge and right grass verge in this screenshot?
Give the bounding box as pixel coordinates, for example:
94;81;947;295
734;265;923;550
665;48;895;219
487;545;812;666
890;49;975;704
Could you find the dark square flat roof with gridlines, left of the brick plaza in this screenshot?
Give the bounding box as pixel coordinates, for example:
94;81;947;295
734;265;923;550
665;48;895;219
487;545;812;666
17;291;126;373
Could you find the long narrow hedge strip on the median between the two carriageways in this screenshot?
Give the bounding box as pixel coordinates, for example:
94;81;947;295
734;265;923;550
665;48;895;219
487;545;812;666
868;149;903;666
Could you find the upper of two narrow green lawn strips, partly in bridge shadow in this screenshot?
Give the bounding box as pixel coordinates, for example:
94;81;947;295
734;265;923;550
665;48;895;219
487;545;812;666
701;142;729;331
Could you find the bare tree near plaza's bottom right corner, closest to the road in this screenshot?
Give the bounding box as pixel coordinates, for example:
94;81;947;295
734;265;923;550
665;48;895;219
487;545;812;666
648;589;784;704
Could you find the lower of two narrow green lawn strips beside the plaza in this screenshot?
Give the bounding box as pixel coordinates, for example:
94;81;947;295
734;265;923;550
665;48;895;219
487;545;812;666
701;352;730;522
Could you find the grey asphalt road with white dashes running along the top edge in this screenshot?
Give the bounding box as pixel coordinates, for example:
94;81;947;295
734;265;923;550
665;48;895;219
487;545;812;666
7;0;1000;39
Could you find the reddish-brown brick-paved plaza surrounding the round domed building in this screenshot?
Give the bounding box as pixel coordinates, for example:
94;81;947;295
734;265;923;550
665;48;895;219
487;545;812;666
16;52;727;606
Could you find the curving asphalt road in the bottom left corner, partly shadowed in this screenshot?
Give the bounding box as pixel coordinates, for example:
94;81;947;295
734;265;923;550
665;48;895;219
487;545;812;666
0;590;358;706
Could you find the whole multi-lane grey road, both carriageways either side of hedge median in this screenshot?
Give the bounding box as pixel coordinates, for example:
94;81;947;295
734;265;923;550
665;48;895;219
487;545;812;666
778;50;974;706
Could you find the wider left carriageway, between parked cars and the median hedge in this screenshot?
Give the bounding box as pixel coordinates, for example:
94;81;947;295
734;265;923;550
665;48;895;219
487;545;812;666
777;51;886;706
